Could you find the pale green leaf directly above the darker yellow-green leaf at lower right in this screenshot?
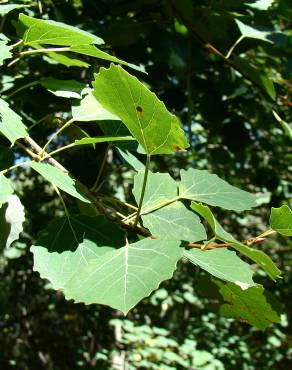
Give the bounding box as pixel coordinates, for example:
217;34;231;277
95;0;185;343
184;248;255;289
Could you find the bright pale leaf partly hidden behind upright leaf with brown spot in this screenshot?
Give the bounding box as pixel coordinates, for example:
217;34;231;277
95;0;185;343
72;93;120;122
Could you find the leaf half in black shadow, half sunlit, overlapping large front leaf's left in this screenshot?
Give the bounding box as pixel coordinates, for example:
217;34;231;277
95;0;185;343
31;215;125;289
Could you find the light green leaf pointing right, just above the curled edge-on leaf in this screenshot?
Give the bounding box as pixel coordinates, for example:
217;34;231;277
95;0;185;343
179;168;256;211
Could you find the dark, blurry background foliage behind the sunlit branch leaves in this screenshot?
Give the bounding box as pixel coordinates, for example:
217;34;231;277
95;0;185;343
0;0;292;370
